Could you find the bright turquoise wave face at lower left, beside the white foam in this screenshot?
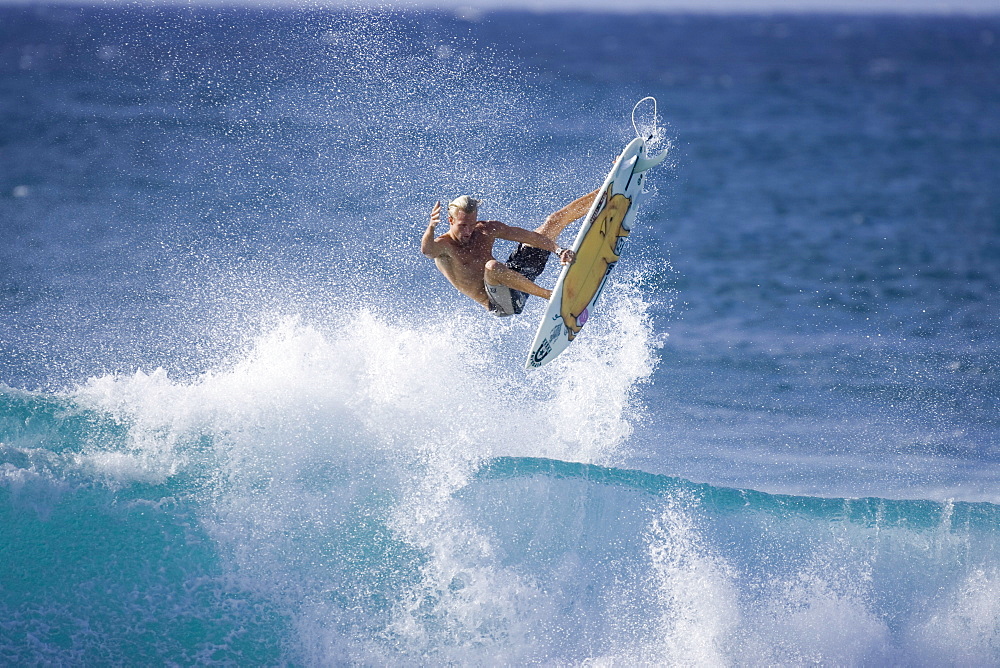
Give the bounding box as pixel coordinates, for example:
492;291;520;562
0;387;286;665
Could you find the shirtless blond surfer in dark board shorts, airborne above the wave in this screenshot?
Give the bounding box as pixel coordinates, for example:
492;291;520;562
420;190;598;316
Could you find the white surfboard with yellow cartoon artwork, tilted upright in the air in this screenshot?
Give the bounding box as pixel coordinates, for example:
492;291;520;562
525;129;667;369
